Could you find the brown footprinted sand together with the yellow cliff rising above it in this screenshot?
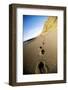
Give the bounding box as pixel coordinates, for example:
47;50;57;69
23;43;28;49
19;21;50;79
23;17;57;74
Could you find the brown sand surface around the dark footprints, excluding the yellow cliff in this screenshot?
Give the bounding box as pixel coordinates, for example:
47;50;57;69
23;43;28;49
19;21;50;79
24;32;57;73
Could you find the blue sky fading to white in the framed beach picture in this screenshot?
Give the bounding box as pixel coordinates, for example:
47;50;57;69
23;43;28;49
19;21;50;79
23;15;48;41
